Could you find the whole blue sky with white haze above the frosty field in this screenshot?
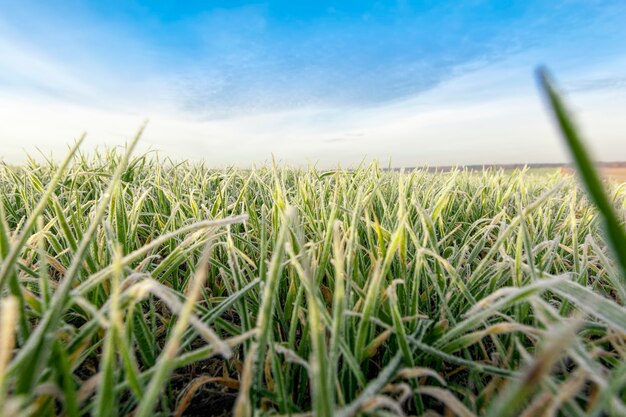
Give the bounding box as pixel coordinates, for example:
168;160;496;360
0;0;626;166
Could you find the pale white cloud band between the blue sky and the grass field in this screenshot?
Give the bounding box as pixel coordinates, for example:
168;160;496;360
0;24;626;166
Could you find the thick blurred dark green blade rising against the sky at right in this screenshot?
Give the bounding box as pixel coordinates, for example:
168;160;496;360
537;68;626;284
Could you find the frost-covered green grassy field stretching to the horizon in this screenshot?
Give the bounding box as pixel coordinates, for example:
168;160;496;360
0;73;626;417
